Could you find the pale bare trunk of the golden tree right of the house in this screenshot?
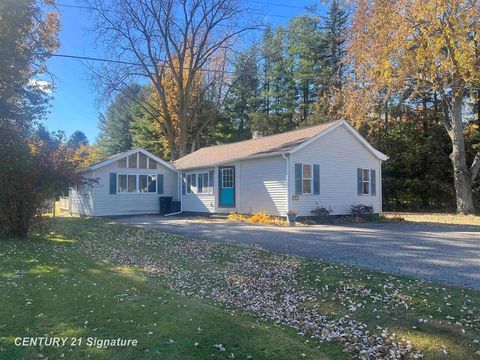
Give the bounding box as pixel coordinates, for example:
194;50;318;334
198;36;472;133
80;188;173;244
448;95;474;214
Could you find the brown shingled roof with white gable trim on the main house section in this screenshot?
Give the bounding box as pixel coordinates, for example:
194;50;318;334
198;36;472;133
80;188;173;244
174;120;388;170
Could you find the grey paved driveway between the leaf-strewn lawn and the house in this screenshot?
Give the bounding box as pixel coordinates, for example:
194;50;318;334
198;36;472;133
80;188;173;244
111;215;480;290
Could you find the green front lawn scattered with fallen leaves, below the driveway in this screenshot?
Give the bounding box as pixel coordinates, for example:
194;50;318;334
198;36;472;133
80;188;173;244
0;218;480;359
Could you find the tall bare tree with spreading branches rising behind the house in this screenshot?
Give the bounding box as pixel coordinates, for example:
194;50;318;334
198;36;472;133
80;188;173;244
85;0;253;159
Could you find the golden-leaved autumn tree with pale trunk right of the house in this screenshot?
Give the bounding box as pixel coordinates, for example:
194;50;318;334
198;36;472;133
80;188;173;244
344;0;480;214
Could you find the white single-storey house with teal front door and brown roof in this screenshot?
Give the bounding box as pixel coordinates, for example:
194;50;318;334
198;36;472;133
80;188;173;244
69;120;388;216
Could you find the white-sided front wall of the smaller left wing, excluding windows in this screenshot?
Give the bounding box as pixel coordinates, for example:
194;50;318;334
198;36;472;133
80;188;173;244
93;162;178;216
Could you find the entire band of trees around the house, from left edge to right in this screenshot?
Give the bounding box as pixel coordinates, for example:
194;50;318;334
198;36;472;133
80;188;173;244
0;0;480;239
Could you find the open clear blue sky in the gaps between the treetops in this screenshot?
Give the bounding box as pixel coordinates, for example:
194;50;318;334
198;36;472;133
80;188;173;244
44;0;326;143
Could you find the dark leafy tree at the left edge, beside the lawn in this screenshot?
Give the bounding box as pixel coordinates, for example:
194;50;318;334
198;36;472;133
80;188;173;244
0;0;80;237
